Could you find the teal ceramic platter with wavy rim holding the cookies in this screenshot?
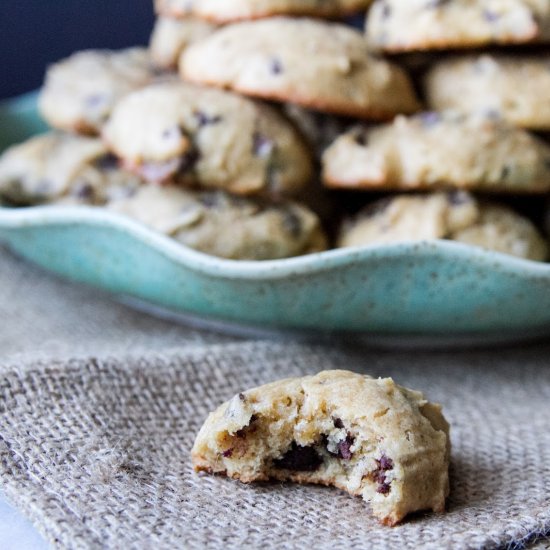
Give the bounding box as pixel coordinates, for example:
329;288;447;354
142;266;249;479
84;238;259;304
0;95;550;338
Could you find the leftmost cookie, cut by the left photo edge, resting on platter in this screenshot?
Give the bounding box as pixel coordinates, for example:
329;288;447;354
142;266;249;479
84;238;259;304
0;132;141;206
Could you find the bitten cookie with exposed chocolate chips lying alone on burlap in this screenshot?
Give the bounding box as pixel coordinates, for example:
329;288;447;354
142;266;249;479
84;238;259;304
192;370;450;525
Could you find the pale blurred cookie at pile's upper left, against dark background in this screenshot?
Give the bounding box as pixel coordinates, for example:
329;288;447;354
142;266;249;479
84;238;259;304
39;48;154;134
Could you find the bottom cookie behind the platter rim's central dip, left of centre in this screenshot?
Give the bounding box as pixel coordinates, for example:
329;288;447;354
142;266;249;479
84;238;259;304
108;184;327;260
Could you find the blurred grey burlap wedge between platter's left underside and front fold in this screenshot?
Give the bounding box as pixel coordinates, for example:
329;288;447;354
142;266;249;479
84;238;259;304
0;246;235;362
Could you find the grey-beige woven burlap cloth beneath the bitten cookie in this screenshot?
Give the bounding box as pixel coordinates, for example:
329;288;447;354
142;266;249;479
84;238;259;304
0;250;550;549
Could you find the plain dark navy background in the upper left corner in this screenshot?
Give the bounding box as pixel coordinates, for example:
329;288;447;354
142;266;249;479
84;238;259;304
0;0;153;98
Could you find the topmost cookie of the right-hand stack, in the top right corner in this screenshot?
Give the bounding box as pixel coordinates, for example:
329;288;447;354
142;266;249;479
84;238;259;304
366;0;550;53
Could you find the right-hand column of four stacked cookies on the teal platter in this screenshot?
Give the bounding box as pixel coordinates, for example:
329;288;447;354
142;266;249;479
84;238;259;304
323;0;550;260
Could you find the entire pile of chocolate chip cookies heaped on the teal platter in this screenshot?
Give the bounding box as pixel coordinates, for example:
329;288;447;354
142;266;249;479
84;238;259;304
0;0;550;260
